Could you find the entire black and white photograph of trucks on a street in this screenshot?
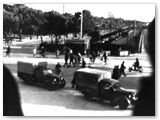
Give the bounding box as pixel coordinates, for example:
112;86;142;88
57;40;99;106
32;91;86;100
1;2;156;117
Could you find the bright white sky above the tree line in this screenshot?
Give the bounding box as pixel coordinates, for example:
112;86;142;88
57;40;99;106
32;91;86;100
25;3;155;22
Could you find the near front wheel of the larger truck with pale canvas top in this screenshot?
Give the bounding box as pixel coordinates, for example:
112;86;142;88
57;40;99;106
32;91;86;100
118;97;130;110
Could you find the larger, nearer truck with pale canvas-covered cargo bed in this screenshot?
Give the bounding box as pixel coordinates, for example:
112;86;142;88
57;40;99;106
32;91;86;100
73;68;137;109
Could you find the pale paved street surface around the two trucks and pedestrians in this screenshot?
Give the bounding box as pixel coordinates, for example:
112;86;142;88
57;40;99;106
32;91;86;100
3;37;152;116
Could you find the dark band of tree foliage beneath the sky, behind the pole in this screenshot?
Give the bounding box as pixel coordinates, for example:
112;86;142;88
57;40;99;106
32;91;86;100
3;4;144;41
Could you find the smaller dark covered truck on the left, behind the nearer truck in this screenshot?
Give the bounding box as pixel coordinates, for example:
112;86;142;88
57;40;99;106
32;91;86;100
17;61;66;90
